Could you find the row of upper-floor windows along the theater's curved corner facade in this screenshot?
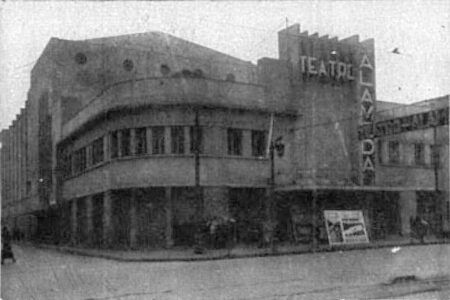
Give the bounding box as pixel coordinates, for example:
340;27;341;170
61;126;267;177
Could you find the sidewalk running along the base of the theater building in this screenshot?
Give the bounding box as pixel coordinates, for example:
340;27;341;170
25;237;450;262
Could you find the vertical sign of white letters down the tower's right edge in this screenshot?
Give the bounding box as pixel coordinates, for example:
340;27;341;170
359;54;375;185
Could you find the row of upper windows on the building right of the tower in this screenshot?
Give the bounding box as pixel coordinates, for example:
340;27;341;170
378;140;439;166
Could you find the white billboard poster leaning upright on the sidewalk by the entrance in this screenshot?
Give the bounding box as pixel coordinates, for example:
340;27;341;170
324;210;369;246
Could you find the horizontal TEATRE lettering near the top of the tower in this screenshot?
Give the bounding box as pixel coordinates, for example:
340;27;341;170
300;55;355;81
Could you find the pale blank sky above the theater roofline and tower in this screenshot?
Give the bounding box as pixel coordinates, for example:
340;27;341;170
0;0;450;129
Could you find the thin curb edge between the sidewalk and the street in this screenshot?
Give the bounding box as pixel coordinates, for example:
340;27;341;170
18;241;450;262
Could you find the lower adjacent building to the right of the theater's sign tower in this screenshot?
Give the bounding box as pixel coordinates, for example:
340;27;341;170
374;95;450;233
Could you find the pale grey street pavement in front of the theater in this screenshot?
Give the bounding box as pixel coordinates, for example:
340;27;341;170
1;244;450;300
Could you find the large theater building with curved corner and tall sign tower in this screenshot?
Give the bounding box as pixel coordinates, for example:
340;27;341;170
1;25;448;248
